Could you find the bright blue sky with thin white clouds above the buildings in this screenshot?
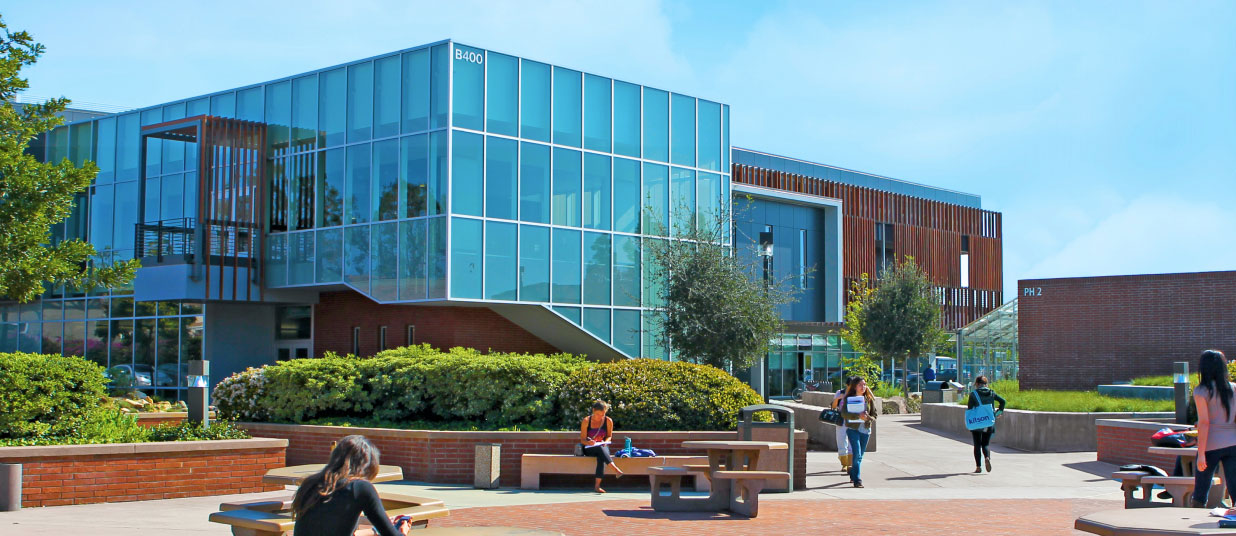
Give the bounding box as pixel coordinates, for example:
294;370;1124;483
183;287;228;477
9;0;1236;299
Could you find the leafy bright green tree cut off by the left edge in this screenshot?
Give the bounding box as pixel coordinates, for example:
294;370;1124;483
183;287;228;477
0;19;140;301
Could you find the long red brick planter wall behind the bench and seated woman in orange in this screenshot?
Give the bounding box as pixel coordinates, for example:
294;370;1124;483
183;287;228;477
239;422;807;489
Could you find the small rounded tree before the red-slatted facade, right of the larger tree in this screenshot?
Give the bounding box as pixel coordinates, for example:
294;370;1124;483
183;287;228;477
858;257;944;396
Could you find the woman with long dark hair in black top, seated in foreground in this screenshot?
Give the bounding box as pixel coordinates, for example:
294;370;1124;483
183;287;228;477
292;436;410;536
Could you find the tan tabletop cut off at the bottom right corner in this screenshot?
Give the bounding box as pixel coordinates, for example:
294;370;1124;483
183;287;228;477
1073;508;1236;536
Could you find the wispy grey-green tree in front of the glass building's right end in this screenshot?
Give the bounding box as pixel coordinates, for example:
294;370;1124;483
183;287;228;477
644;200;796;371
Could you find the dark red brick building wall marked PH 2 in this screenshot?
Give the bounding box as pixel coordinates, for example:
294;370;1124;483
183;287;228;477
1017;272;1236;389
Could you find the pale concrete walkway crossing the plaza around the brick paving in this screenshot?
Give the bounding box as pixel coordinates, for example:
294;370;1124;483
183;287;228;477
0;415;1121;536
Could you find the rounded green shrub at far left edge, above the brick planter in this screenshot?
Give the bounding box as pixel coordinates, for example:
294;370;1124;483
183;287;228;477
0;352;108;438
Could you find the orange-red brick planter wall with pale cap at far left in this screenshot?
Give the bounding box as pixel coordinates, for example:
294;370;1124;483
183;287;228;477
0;438;288;508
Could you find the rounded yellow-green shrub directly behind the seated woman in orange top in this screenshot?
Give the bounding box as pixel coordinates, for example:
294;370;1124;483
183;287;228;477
560;359;763;430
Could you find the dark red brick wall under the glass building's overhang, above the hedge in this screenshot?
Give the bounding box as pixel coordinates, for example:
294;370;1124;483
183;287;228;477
313;290;559;356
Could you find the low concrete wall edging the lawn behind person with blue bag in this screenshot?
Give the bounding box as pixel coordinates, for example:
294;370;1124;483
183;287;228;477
922;404;1173;452
